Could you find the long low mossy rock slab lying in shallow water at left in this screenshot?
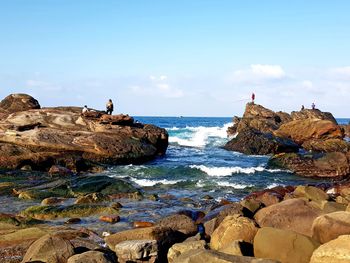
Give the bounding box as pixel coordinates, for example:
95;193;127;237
21;204;118;220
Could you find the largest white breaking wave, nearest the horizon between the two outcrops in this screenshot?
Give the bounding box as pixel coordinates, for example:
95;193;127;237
169;123;232;147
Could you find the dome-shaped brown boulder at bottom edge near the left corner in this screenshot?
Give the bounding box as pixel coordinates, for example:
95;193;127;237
23;235;74;263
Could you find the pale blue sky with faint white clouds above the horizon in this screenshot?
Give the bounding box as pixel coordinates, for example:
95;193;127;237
0;0;350;118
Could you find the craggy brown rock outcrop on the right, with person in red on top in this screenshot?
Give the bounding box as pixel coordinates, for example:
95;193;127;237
224;103;350;178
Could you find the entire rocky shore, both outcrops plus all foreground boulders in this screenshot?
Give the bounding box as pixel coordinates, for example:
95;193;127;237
0;94;350;263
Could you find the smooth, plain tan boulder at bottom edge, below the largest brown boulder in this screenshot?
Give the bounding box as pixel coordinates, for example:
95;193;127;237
254;227;319;263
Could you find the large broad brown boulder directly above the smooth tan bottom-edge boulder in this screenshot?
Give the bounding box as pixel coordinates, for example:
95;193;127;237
254;198;323;237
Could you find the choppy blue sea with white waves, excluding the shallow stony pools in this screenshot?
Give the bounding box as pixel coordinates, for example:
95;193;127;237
107;117;350;203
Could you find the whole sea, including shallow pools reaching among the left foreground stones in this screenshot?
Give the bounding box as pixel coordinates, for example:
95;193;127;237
0;117;350;233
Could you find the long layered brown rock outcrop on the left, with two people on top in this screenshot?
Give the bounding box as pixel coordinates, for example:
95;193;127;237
0;95;168;172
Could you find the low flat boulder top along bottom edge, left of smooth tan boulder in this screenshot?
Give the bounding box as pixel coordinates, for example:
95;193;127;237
174;249;278;263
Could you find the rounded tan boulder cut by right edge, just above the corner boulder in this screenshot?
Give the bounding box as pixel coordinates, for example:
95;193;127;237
312;211;350;244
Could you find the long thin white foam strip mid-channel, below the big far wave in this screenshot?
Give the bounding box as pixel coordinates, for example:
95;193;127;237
190;165;265;176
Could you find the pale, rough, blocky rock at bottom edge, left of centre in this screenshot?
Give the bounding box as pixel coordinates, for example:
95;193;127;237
114;239;158;263
